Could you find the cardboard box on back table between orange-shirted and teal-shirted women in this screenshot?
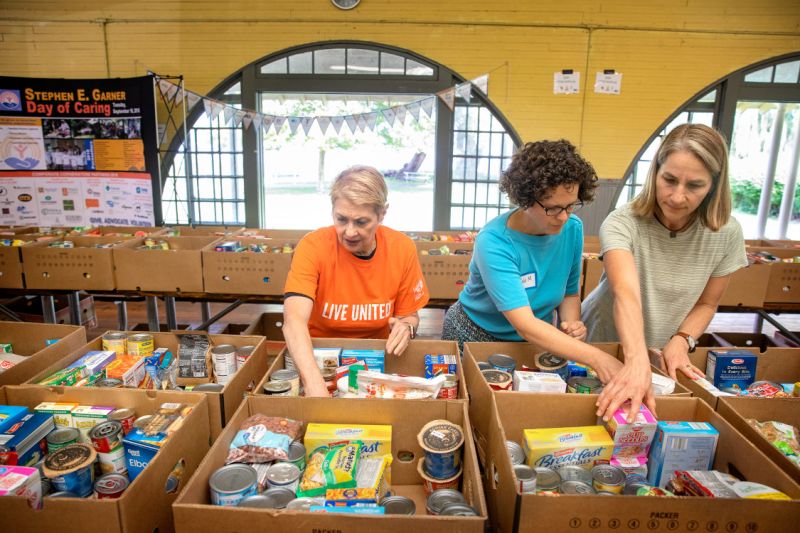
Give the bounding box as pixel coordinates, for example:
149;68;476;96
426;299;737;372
416;241;474;300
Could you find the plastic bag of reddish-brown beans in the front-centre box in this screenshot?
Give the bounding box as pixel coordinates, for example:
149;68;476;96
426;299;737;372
225;414;303;464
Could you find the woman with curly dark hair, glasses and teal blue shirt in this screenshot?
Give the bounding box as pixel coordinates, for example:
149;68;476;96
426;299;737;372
442;140;622;383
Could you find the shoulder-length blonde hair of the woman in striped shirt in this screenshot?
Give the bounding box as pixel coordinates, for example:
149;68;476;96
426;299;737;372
631;124;731;231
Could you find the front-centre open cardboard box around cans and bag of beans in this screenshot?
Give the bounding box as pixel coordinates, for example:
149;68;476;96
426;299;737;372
172;396;487;533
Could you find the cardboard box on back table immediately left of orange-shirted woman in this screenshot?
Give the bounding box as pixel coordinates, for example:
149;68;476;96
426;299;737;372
202;237;297;296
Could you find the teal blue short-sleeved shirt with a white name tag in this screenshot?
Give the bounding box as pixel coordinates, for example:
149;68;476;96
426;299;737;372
458;211;583;341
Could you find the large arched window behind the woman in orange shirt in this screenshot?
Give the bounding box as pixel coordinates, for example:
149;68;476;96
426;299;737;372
162;42;520;231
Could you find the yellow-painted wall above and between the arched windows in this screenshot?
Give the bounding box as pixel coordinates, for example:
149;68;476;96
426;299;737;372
0;0;800;178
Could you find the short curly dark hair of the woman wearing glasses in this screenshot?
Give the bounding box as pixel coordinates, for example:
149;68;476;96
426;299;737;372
500;139;597;209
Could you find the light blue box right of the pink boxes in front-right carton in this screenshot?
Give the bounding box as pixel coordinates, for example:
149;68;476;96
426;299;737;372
647;422;719;488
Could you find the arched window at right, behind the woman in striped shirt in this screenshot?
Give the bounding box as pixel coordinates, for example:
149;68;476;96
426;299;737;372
616;54;800;239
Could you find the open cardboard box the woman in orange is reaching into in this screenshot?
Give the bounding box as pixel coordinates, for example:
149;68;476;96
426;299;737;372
253;338;469;400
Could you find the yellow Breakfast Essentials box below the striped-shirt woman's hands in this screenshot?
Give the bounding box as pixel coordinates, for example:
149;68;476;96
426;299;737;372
522;426;614;469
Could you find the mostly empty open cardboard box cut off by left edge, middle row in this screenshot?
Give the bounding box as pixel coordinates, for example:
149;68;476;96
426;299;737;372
0;321;86;386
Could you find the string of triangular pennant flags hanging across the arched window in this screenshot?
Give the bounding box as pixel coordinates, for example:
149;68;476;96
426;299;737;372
155;74;489;135
